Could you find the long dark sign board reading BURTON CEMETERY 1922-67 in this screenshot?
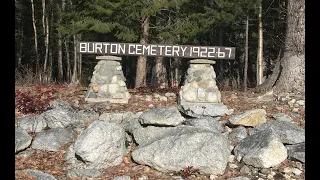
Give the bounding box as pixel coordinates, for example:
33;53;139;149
77;42;235;59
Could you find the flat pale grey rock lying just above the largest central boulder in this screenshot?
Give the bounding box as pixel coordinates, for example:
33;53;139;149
139;106;185;126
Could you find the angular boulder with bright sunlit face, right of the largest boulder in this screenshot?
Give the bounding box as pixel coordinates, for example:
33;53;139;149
234;129;288;168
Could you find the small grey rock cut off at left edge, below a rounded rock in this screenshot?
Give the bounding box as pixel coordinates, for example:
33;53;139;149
14;129;32;153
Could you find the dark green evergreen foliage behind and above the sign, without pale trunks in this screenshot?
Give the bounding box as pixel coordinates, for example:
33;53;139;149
15;0;286;89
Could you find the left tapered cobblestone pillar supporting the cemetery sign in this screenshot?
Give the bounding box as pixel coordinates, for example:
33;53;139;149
85;56;130;103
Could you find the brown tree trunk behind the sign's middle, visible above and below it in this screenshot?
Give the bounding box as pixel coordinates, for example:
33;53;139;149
135;15;149;88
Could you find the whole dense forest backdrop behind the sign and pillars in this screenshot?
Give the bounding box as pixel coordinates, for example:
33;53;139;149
15;0;288;90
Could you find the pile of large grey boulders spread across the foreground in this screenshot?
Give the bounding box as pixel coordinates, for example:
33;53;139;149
15;102;305;179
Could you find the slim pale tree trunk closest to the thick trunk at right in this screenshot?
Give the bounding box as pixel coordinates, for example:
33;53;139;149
257;0;263;85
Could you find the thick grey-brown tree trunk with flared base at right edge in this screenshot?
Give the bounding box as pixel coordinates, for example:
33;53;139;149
255;0;305;94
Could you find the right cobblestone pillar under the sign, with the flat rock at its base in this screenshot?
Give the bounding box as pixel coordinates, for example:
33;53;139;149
178;59;229;117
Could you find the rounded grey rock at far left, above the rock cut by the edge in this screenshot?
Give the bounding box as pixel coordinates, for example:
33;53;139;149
17;115;47;133
